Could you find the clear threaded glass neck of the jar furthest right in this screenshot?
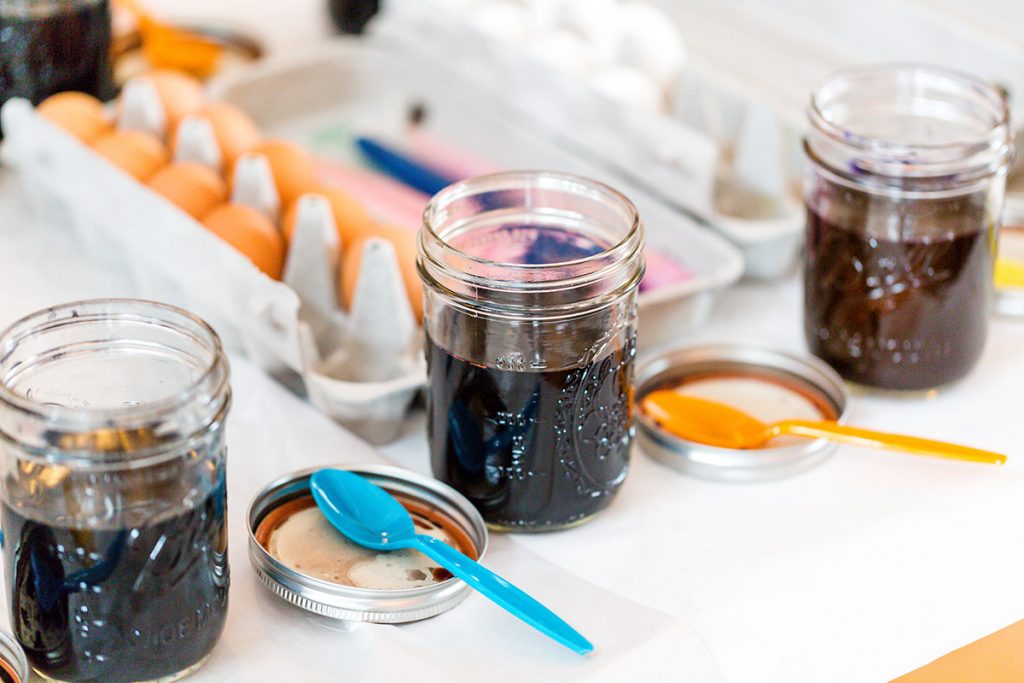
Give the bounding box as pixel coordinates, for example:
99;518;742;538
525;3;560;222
805;65;1013;197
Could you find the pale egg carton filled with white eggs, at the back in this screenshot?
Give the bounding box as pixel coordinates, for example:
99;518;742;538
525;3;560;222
380;0;804;279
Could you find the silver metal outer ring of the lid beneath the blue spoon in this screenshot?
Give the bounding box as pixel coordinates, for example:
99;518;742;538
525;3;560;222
246;465;487;624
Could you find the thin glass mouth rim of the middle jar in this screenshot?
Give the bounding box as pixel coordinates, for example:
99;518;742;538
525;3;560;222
421;170;641;285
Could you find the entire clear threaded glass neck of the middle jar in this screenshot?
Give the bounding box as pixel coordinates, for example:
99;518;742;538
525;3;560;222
418;171;644;317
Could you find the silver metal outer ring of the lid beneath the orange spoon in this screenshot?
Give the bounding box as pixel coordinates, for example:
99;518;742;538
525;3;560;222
637;344;849;481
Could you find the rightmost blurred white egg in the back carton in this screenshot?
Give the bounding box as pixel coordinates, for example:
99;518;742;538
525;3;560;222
618;0;686;85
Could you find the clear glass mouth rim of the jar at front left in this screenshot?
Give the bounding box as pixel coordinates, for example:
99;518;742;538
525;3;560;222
0;297;227;425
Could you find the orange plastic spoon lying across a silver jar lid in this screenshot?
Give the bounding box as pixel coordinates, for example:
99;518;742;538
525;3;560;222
641;389;1007;465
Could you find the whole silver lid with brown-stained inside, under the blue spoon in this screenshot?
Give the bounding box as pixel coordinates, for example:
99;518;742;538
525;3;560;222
248;465;487;624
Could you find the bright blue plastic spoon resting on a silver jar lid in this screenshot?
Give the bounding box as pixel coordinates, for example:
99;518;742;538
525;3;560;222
309;469;594;654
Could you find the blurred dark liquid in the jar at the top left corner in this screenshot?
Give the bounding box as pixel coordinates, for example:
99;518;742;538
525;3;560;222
0;0;114;104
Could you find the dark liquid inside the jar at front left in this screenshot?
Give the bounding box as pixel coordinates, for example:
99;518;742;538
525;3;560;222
3;483;228;683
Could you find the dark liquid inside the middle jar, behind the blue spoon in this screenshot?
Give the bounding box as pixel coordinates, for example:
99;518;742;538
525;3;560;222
427;340;635;530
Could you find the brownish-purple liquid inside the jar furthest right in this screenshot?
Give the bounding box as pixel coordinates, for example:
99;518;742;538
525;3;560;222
804;180;994;390
